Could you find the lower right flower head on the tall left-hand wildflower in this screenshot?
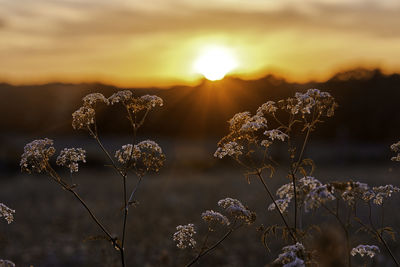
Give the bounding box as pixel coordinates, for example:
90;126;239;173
115;140;165;173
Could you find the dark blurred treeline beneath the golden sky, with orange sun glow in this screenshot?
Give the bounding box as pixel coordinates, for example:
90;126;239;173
0;69;400;142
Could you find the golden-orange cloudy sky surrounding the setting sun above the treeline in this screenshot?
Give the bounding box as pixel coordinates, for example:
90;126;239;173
0;0;400;86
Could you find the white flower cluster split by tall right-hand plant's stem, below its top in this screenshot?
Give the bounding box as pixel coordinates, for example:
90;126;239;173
268;176;335;212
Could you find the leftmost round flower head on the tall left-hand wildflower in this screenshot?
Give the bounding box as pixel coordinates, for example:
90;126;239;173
20;138;56;173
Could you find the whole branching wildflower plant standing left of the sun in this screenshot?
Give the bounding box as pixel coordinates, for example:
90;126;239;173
19;90;165;266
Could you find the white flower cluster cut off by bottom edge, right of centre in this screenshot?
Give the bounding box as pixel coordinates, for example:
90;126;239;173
274;242;306;267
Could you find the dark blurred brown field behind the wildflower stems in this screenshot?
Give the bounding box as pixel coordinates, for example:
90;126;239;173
0;144;400;266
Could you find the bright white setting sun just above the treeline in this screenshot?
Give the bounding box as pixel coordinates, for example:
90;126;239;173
194;46;238;81
